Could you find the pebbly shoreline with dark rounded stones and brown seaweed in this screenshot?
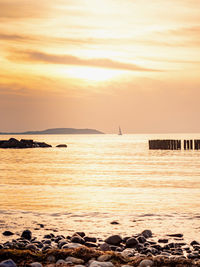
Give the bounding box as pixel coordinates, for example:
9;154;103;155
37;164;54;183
0;229;200;267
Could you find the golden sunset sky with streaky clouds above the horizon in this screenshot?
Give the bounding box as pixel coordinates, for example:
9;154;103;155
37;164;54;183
0;0;200;133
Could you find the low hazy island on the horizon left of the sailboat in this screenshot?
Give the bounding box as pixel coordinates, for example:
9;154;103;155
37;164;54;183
0;128;104;135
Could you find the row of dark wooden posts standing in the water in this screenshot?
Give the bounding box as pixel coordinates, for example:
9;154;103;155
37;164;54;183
149;139;200;150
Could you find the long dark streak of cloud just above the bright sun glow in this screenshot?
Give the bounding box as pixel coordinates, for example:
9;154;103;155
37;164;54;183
8;51;159;71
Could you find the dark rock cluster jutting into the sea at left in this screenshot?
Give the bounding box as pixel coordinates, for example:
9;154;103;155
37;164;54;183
0;138;52;148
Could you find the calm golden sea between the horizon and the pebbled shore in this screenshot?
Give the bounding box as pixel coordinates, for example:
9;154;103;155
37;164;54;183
0;134;200;242
